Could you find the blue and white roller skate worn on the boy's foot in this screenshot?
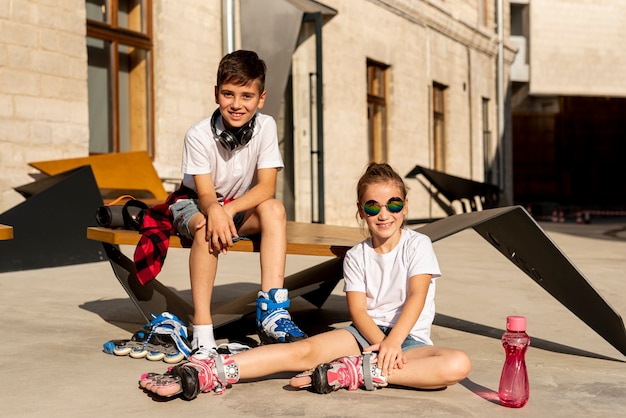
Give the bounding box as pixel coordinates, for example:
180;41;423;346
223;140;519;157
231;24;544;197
256;289;307;344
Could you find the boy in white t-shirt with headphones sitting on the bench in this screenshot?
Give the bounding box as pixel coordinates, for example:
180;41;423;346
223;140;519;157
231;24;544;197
135;50;306;358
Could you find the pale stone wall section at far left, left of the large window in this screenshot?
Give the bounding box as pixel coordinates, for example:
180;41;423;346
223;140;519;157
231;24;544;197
0;0;89;212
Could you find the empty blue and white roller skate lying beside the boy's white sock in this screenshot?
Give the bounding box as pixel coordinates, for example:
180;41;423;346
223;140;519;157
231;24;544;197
103;312;191;364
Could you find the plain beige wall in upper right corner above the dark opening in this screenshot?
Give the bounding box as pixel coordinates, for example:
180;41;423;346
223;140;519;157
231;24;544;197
529;0;626;97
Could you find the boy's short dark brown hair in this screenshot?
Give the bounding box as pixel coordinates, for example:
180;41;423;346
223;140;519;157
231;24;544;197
217;50;267;93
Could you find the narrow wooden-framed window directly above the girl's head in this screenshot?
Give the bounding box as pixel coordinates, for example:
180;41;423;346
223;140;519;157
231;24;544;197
367;60;389;162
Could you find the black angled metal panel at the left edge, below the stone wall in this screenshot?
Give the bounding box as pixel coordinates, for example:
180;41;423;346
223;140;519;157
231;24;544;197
0;166;105;272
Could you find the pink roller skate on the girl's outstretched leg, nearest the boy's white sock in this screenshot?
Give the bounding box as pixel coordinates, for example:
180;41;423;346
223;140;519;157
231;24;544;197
139;354;239;401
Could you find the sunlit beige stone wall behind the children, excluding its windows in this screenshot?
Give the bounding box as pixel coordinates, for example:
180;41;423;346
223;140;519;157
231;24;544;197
0;0;513;225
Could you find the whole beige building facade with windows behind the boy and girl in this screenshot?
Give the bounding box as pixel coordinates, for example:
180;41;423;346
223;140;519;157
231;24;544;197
0;0;516;225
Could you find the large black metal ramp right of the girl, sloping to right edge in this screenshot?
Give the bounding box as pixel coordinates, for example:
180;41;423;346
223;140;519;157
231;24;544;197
415;206;626;355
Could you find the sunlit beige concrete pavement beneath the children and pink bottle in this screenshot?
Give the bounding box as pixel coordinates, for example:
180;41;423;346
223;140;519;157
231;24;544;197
0;222;626;417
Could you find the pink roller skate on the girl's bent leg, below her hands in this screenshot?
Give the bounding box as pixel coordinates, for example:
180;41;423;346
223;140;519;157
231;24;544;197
311;352;387;393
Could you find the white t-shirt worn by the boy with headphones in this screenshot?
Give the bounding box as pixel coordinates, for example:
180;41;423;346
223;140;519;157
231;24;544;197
182;113;284;202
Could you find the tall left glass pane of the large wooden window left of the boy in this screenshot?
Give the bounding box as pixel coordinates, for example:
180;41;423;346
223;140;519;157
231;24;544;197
87;37;113;154
